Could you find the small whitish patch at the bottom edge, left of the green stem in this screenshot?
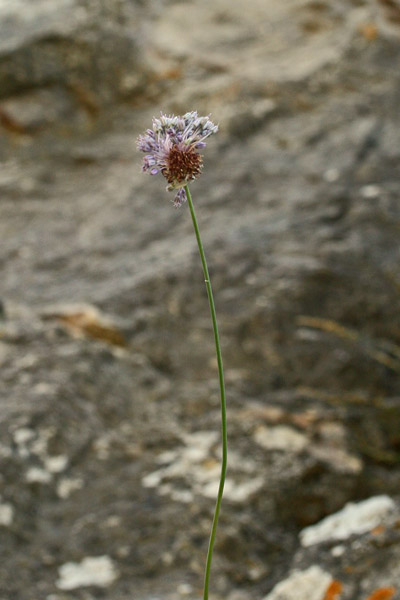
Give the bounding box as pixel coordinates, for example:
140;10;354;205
56;556;118;590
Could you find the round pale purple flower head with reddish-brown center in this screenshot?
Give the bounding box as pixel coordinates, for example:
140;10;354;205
137;111;218;206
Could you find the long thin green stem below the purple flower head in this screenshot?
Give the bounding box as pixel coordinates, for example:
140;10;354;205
185;185;228;600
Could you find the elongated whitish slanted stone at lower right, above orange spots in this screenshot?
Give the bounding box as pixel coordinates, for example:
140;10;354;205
300;496;395;546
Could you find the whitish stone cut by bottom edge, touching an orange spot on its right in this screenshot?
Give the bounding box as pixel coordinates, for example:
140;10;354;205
264;565;332;600
